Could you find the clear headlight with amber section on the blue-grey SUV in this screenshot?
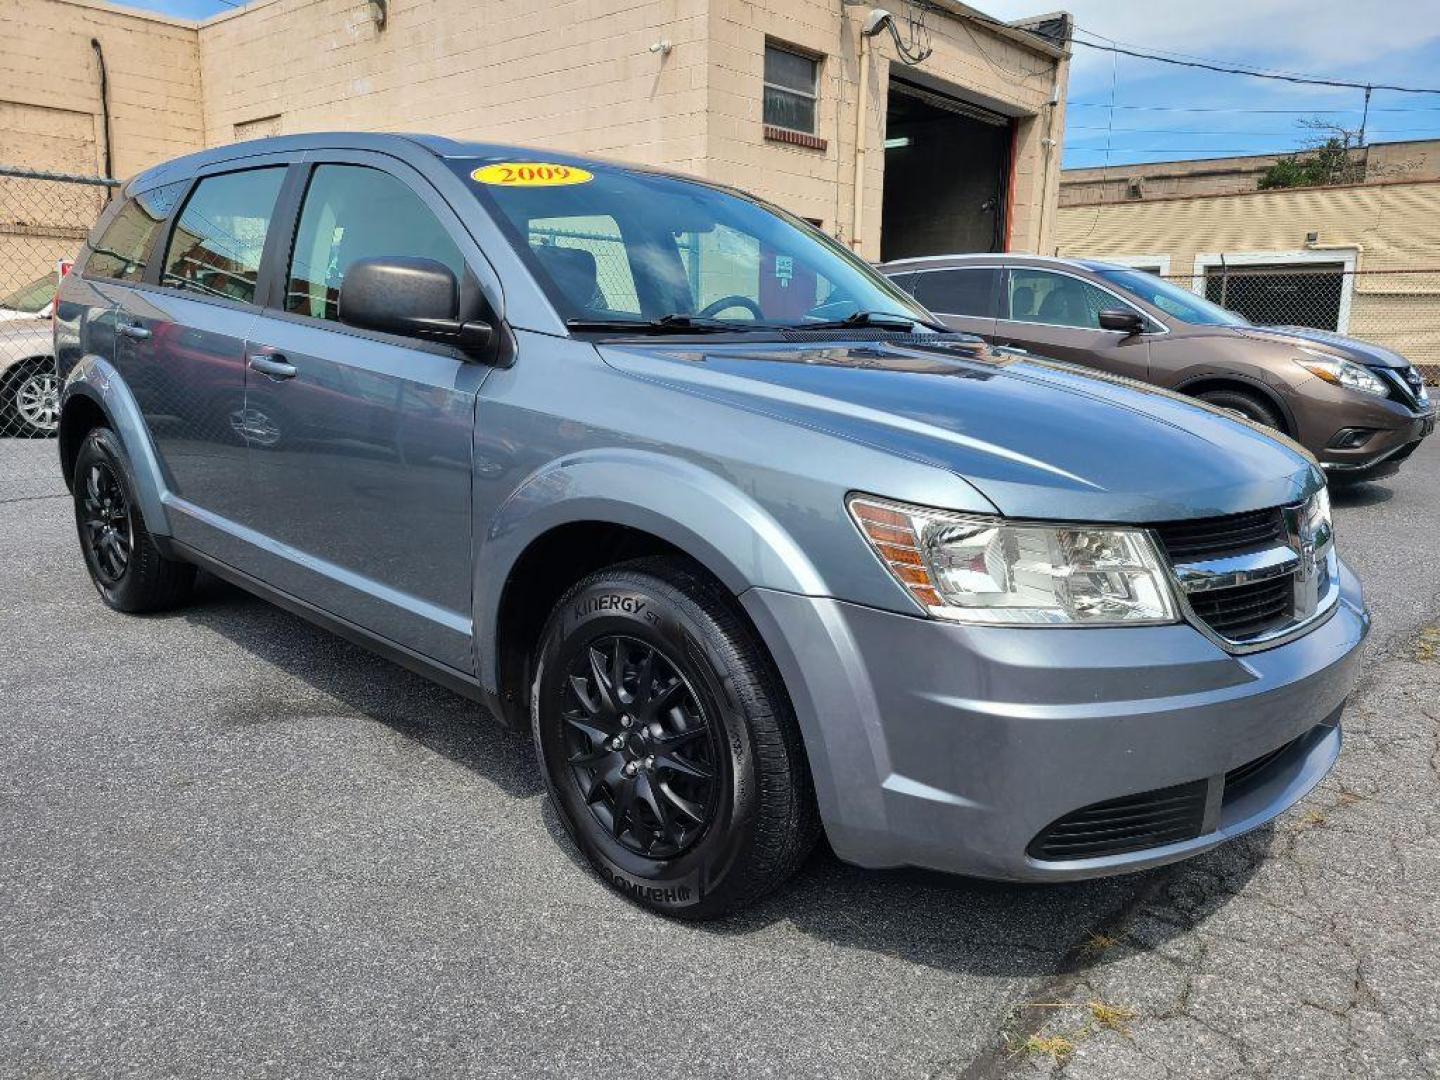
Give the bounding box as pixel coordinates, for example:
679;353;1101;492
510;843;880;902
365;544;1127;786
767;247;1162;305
850;495;1176;626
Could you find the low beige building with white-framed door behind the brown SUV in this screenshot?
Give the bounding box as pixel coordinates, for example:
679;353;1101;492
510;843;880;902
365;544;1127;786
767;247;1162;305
1047;141;1440;372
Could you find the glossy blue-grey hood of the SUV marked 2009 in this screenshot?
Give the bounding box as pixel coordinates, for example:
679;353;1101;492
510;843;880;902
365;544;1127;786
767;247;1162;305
600;337;1322;521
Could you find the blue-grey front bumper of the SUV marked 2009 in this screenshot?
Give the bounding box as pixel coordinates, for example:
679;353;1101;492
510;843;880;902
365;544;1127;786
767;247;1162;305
742;563;1369;881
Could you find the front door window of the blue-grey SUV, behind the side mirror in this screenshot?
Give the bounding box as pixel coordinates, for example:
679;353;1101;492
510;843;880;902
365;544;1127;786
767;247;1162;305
285;166;465;321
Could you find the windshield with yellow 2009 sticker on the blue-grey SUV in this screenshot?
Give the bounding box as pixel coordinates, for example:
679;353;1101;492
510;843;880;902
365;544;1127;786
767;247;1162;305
454;160;929;330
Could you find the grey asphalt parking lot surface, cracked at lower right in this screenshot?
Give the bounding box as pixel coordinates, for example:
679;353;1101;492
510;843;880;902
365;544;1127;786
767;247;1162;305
0;441;1440;1080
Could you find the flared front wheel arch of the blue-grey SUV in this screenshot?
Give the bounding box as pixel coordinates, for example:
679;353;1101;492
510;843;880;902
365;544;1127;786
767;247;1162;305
475;448;827;693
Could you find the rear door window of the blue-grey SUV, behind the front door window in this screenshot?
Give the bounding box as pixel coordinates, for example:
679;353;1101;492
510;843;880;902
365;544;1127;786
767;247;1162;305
161;166;285;304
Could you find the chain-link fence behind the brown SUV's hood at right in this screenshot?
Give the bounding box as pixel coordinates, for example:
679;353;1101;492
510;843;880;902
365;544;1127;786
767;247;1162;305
1166;261;1440;384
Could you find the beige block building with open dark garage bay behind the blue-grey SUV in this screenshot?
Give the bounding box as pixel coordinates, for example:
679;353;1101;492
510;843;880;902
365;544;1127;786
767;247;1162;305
0;0;1068;270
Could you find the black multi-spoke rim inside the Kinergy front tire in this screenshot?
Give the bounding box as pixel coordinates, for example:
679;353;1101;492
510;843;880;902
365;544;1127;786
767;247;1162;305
563;634;719;858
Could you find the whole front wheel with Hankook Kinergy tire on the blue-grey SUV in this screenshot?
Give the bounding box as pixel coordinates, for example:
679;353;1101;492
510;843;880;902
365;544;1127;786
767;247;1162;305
531;559;819;919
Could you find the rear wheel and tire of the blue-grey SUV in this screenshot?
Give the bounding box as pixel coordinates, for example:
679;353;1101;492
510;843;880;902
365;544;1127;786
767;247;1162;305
71;428;194;612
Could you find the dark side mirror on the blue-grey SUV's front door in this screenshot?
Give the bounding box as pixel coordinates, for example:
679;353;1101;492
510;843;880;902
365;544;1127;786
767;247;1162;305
340;255;494;354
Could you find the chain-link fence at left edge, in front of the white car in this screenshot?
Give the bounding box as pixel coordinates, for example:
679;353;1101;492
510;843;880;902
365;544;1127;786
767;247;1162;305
0;166;117;503
